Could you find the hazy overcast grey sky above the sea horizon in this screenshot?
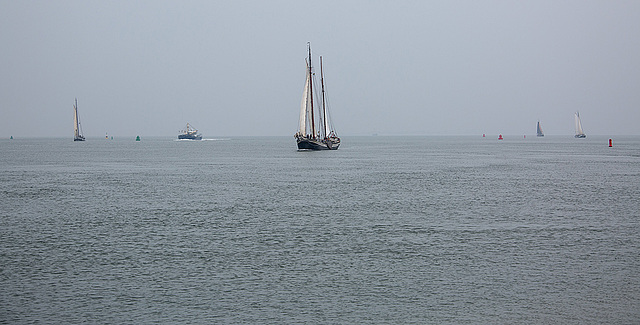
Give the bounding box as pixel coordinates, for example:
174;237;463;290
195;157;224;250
0;0;640;137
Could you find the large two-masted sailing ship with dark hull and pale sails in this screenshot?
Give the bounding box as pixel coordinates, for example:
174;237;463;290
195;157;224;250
294;43;340;150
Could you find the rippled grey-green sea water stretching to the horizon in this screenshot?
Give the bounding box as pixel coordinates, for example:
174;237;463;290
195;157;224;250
0;137;640;324
